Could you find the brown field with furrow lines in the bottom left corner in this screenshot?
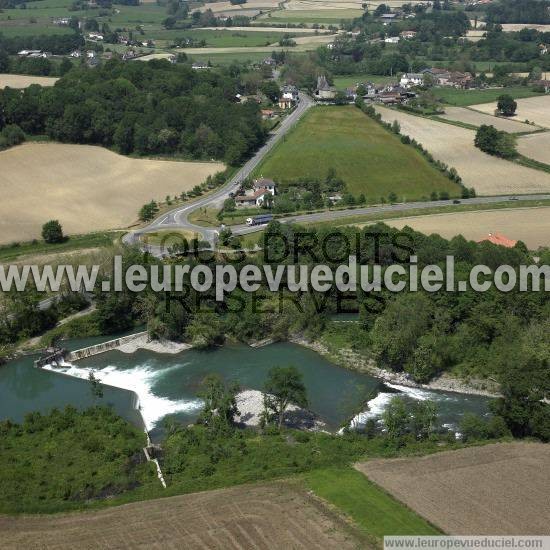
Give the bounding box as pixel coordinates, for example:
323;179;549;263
0;483;365;550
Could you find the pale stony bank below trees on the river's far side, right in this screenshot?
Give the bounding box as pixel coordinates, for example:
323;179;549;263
289;336;500;397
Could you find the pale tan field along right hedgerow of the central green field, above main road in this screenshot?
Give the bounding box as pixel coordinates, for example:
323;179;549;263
376;106;550;195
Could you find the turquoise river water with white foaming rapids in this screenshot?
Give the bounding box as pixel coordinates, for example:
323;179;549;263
0;339;489;439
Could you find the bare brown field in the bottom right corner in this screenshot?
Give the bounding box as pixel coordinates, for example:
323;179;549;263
356;442;550;535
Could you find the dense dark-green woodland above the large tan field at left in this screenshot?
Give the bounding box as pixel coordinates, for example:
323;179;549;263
0;60;265;164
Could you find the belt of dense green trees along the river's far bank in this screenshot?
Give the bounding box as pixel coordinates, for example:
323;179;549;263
4;222;550;439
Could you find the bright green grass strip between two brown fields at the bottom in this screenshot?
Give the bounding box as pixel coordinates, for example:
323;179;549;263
305;467;441;541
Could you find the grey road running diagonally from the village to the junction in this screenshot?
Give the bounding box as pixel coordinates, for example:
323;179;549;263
123;93;315;250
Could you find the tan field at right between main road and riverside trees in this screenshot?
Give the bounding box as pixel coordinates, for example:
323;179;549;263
384;206;550;250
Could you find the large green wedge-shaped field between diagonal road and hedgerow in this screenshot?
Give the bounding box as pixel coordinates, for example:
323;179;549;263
255;106;460;201
